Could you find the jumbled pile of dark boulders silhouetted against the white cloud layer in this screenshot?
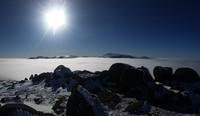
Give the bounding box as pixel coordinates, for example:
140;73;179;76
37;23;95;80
27;63;200;113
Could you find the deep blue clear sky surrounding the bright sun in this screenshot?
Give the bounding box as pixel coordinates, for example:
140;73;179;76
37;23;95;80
0;0;200;58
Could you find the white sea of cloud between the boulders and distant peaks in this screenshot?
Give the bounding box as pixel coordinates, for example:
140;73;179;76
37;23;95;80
0;57;200;80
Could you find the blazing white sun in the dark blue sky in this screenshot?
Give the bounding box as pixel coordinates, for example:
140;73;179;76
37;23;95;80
45;9;66;31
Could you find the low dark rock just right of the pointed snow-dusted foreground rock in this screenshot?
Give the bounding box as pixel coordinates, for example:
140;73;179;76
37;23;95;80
97;91;121;109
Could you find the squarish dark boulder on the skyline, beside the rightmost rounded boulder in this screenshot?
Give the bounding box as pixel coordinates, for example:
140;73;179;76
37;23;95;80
153;66;173;83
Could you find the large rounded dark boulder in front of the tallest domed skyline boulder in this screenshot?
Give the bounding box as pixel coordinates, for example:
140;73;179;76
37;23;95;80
120;67;146;89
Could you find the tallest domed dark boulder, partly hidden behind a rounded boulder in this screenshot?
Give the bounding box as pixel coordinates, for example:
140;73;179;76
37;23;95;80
109;63;132;84
